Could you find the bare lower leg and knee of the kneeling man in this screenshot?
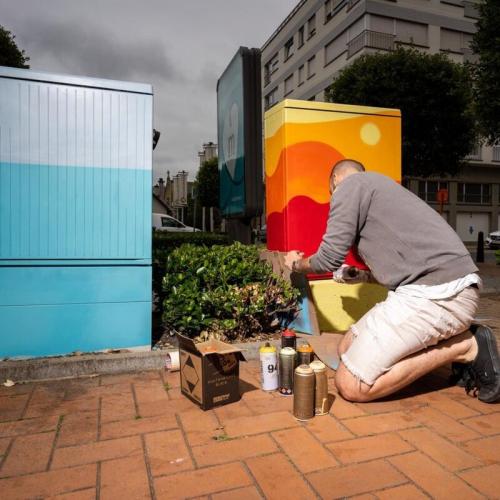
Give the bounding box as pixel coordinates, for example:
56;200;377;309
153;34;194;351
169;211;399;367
335;330;477;402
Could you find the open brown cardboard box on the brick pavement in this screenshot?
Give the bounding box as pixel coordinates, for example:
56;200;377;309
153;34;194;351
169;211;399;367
177;335;246;410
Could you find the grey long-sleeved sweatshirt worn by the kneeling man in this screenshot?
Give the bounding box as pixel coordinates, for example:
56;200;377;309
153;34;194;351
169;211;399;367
310;172;478;290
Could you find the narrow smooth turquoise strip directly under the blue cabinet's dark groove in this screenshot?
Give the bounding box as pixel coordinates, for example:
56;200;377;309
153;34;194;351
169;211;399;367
0;266;151;306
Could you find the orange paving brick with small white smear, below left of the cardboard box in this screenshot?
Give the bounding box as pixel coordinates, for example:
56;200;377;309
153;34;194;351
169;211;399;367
145;430;194;476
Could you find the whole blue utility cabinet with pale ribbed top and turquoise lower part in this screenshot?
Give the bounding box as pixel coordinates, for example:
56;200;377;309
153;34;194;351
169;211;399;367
0;67;153;357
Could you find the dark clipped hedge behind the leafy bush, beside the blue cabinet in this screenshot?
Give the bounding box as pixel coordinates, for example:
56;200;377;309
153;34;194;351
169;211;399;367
152;231;229;308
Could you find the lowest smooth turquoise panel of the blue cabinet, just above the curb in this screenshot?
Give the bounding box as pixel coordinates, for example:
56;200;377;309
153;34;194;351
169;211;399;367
0;302;151;357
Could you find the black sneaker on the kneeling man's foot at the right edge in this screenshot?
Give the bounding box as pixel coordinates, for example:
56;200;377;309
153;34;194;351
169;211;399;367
462;325;500;403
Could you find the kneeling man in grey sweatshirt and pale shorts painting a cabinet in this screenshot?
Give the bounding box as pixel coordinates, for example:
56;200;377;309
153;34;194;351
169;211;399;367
285;160;500;403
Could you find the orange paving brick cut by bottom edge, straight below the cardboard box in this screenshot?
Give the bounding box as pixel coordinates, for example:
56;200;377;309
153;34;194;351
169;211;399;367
155;463;252;500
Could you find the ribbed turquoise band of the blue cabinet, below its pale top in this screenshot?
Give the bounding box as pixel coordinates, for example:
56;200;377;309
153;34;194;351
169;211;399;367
0;162;152;264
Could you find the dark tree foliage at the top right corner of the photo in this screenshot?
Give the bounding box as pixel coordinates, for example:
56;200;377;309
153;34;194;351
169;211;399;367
472;0;500;145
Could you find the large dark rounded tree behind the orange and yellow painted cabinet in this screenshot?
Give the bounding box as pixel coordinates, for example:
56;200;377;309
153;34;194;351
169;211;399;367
327;48;476;177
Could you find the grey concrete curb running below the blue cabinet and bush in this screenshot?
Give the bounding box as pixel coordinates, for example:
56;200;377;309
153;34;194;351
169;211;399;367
0;340;286;383
